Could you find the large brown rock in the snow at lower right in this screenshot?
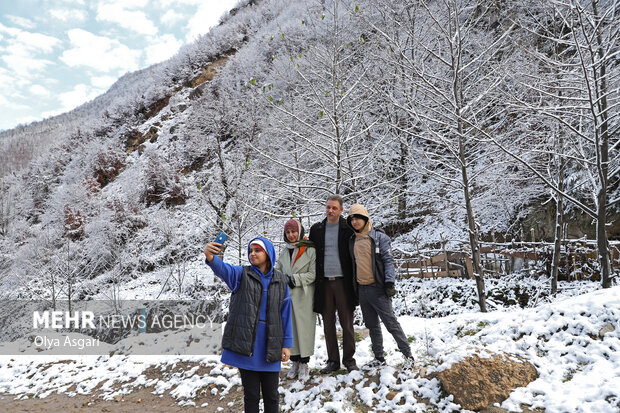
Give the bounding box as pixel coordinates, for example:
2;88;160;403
436;355;538;410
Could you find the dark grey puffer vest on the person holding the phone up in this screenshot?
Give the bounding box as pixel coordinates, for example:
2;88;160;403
222;266;287;363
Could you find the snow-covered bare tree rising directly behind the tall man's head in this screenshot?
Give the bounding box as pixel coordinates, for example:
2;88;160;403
250;0;385;212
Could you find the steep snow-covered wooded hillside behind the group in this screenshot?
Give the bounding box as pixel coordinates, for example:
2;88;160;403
0;0;620;298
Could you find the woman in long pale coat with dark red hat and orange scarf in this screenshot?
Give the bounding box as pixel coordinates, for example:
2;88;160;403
275;219;316;381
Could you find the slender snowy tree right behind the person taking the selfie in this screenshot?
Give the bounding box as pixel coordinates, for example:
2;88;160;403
190;61;267;263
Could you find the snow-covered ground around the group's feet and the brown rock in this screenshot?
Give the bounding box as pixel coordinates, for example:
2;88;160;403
0;286;620;412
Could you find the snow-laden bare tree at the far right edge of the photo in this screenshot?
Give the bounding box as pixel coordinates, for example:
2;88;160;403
490;0;620;288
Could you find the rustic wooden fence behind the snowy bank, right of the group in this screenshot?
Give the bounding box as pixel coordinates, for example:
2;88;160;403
394;239;620;280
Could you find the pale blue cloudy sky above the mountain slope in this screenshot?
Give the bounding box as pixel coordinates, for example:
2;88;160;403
0;0;238;130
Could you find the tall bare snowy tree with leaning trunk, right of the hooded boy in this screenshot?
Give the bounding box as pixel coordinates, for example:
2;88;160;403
366;0;513;311
